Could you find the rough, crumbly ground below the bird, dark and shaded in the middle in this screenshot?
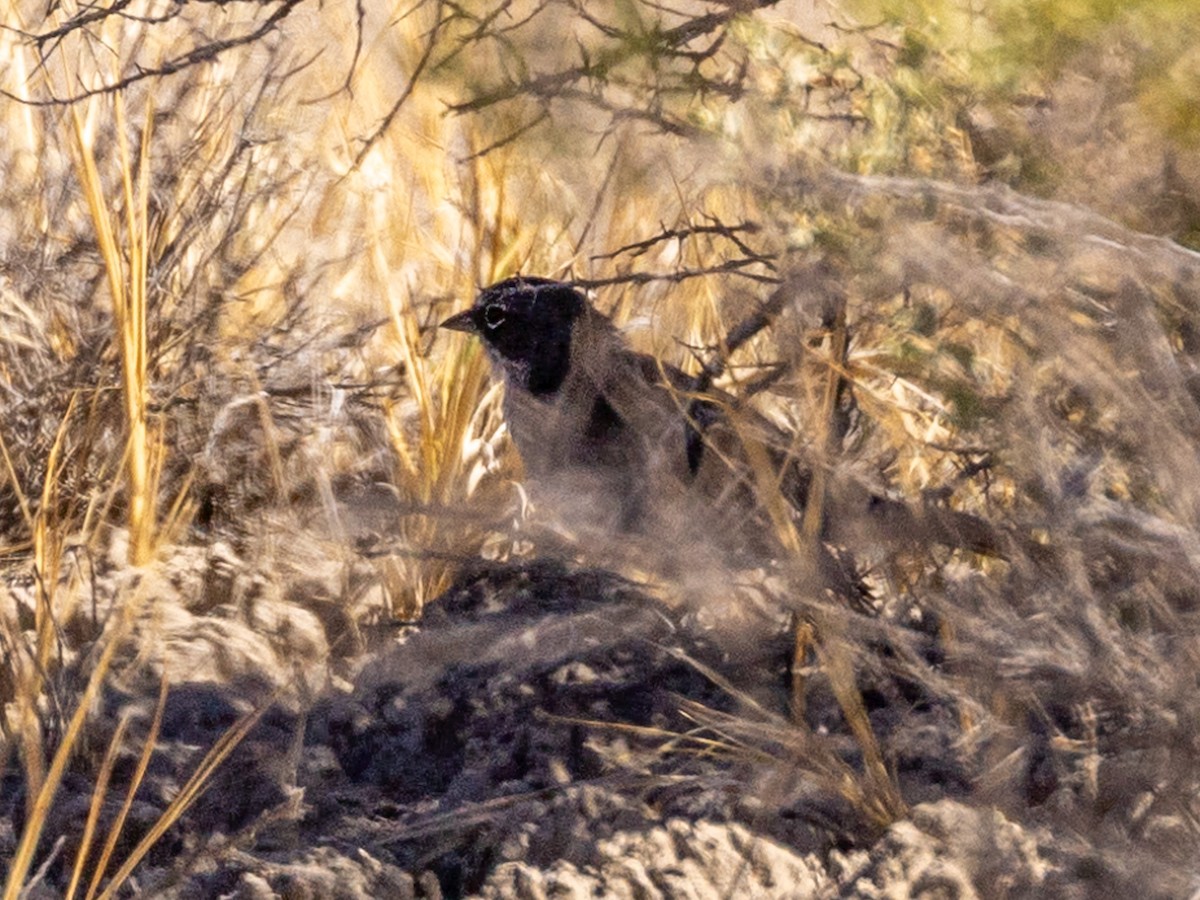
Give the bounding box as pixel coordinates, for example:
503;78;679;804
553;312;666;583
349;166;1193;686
0;525;1182;898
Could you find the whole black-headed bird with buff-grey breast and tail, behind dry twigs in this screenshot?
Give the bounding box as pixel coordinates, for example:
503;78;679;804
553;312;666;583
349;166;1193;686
440;275;994;598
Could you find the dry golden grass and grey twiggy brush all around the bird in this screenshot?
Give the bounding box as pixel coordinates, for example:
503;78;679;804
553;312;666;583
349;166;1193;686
0;0;1200;898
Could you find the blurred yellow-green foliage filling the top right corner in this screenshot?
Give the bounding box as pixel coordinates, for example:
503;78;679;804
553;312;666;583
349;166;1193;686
851;0;1200;246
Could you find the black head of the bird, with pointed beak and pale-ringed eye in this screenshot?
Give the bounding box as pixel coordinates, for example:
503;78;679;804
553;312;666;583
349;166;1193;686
440;276;587;397
